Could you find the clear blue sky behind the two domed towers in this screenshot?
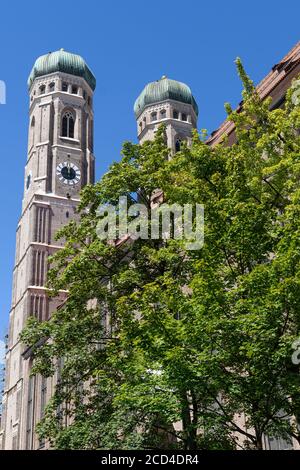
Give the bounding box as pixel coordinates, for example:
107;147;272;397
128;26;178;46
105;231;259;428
0;0;300;338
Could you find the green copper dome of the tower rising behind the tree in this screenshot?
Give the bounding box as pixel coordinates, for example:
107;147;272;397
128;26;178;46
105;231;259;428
134;76;198;117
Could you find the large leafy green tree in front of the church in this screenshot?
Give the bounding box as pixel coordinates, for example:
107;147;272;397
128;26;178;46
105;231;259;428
22;60;300;449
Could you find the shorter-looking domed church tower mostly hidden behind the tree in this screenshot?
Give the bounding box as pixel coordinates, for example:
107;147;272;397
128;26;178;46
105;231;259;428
134;76;198;153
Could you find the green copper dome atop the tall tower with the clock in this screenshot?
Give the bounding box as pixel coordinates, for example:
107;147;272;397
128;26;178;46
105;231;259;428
28;49;96;90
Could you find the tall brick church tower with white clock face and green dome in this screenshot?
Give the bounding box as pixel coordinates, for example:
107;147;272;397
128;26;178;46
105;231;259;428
0;49;96;449
